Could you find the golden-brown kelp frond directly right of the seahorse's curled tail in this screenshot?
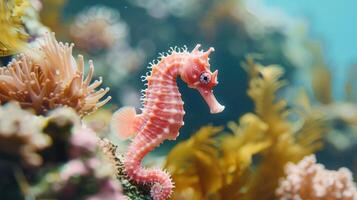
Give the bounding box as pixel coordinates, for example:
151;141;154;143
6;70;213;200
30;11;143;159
165;126;222;200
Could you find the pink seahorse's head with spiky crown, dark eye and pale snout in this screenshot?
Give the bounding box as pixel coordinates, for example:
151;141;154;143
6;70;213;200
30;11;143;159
180;44;224;113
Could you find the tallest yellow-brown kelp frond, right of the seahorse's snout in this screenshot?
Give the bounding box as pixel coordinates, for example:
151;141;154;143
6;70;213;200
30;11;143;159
242;57;326;200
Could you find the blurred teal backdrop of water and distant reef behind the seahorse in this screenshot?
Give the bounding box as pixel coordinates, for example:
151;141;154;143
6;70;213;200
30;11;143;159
25;0;357;166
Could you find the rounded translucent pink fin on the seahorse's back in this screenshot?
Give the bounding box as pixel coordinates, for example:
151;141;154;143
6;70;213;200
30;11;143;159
111;106;137;140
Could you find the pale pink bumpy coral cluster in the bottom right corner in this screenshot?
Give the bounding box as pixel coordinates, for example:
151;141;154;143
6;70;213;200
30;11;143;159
276;155;357;200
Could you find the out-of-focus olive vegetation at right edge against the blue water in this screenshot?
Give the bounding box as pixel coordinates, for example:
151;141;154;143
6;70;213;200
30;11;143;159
307;55;357;152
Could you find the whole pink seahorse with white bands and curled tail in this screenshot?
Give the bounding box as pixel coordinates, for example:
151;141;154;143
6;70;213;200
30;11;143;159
112;44;224;200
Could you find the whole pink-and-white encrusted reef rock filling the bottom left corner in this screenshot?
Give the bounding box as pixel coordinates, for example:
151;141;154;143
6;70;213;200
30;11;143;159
0;104;135;200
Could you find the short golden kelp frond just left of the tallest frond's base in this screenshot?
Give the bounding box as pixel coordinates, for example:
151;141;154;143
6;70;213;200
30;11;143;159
219;113;271;200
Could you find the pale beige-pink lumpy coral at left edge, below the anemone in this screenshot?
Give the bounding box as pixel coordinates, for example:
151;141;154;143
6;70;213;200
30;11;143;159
0;103;51;166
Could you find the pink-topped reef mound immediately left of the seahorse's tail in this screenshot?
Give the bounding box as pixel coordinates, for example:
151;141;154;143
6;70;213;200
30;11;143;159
38;128;128;200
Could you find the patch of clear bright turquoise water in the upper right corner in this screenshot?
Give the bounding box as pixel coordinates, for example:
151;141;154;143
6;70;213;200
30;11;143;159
265;0;357;100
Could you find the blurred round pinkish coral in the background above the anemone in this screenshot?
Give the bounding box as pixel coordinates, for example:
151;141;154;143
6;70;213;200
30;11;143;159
70;6;128;53
